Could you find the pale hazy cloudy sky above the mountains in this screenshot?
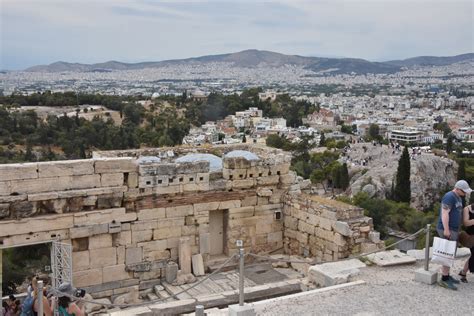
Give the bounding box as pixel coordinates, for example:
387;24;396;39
0;0;474;69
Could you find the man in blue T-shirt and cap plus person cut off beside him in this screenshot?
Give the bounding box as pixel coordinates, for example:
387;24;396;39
436;180;474;290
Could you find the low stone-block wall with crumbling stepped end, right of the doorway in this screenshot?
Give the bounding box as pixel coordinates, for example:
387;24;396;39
284;194;383;262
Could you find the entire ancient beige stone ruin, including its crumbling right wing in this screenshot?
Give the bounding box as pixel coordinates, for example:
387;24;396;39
0;144;380;298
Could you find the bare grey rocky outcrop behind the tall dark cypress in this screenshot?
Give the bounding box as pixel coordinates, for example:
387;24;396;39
347;144;457;210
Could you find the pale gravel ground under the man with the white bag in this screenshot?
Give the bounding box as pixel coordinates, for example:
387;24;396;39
255;258;474;316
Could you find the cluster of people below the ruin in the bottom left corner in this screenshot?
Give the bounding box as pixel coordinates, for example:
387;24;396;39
1;276;85;316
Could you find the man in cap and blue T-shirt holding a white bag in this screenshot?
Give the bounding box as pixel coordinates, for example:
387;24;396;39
436;180;472;290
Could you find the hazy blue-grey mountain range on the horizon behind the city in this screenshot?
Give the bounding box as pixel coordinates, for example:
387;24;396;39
25;49;474;74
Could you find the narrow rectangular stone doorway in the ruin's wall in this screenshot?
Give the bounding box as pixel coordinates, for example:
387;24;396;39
209;210;227;256
